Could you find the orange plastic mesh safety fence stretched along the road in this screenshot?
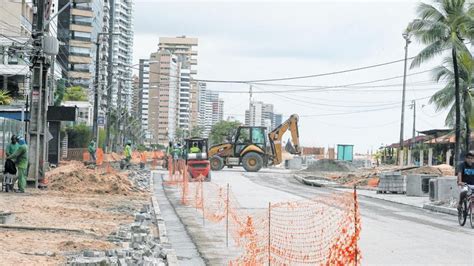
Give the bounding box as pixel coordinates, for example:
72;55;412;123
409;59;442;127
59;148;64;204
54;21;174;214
166;169;361;265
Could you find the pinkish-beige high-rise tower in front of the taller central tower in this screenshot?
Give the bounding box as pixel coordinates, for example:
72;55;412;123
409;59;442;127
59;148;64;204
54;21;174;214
148;49;179;145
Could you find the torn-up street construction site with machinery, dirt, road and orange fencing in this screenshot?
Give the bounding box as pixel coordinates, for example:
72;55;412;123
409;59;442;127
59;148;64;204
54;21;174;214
0;112;474;266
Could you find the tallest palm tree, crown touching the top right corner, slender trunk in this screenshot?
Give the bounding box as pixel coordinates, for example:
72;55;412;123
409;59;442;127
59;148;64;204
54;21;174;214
409;0;474;163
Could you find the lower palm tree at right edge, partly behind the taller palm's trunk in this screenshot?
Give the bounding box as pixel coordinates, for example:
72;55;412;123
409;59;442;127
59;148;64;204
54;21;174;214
429;52;474;151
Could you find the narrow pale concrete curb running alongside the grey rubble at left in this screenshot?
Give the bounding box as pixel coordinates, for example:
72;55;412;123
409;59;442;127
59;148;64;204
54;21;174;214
150;173;179;266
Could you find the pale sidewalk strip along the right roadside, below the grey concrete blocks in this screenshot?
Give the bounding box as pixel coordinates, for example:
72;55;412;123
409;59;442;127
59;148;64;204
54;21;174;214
295;176;458;215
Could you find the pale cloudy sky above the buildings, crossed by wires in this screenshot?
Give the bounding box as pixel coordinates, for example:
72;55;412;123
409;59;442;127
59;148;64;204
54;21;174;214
133;0;452;153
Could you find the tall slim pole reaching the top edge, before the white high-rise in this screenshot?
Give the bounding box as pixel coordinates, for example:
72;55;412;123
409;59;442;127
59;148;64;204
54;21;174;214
105;0;115;152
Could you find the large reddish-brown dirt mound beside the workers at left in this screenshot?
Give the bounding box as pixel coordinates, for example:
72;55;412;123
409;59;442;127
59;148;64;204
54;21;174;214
47;162;139;195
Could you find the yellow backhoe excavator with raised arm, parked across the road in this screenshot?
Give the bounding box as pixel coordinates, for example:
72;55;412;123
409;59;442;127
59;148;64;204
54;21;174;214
208;114;301;172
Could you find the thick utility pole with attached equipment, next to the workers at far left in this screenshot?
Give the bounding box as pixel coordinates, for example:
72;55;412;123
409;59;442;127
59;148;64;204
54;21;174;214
28;0;49;188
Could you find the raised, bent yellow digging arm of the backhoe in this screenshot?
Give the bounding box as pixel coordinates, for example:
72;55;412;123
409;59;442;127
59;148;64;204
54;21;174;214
268;114;301;165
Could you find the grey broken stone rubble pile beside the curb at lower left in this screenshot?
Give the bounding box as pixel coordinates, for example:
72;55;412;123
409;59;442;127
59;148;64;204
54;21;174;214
67;205;168;266
